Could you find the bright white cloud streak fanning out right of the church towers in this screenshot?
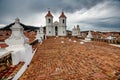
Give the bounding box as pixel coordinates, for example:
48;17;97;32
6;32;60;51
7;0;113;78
68;1;120;22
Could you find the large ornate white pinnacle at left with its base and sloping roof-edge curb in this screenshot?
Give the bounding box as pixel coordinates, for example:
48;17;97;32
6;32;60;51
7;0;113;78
5;18;35;80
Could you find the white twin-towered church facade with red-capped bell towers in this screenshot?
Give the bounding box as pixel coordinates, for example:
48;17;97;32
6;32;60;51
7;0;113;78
45;11;67;36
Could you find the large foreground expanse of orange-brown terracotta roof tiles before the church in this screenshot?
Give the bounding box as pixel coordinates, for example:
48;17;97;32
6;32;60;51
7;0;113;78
19;37;120;80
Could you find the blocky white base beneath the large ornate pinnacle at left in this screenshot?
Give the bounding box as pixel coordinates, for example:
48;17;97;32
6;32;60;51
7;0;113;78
11;45;32;65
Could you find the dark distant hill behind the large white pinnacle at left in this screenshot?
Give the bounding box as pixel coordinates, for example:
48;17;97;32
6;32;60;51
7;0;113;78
0;23;39;31
